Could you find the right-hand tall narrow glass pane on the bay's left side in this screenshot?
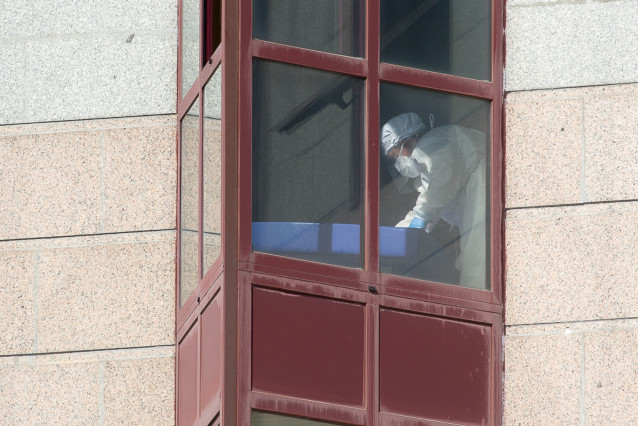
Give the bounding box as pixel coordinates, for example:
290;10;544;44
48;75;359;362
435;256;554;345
202;66;222;274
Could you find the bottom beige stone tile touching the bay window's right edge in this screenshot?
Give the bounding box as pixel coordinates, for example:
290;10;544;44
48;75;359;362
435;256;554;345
503;335;583;426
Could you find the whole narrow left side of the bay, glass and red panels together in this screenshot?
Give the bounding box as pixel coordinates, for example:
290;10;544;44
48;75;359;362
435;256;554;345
175;0;226;425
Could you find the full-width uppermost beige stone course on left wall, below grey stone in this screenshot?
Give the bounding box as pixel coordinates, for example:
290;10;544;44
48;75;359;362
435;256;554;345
0;116;177;240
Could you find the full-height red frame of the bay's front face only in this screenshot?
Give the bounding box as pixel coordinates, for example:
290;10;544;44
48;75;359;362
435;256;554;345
237;0;504;425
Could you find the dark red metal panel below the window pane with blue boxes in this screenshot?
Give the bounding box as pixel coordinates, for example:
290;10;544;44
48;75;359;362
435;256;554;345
252;287;366;406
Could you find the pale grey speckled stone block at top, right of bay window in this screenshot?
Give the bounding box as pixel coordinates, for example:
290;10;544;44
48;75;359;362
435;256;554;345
506;0;638;91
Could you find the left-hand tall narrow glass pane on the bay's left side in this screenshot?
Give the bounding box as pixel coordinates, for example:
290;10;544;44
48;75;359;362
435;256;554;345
179;99;199;306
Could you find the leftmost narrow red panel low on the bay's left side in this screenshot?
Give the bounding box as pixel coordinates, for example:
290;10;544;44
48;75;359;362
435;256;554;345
177;323;199;426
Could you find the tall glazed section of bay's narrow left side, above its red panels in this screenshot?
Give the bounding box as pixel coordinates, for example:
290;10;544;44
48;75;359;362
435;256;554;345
178;0;222;308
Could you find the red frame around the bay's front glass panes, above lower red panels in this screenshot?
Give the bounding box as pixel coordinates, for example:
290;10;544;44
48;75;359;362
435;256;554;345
238;0;503;313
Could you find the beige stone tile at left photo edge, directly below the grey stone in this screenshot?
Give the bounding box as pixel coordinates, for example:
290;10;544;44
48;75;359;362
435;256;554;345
0;132;101;240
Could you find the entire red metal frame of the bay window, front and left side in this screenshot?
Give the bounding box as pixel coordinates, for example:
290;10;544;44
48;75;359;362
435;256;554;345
176;0;504;424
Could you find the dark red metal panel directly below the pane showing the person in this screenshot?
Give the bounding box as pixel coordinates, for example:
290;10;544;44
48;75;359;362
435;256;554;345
379;308;492;425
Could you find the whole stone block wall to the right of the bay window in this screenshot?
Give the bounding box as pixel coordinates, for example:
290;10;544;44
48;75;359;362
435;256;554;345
504;0;638;425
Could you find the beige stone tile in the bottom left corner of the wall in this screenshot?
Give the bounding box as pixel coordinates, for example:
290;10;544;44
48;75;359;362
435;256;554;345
0;363;100;425
